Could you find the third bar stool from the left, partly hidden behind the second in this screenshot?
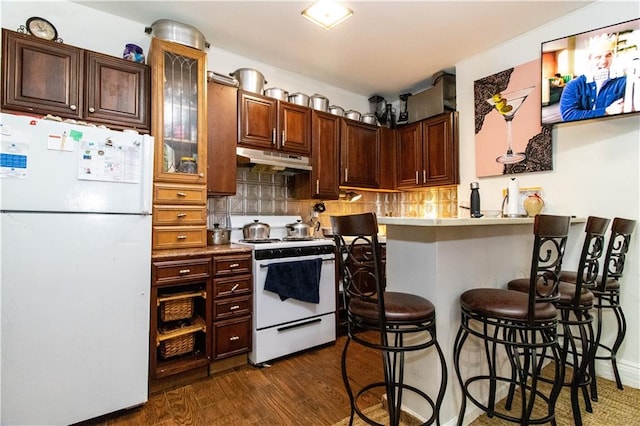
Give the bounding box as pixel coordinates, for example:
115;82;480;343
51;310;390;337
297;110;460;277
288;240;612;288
507;216;610;426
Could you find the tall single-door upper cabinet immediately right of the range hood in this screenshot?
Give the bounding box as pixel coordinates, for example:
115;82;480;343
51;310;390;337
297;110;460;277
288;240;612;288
295;110;342;200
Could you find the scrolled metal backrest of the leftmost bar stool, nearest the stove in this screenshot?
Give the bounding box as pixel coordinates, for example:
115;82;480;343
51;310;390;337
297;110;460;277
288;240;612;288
331;213;386;327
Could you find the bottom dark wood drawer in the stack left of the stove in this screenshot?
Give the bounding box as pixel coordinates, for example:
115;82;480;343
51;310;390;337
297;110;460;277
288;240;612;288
213;316;251;359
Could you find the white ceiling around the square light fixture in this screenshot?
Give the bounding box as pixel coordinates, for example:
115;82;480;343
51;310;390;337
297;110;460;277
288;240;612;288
76;0;593;98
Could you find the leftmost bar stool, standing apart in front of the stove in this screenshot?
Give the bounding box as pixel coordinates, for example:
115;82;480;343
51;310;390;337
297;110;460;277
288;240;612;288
331;213;447;425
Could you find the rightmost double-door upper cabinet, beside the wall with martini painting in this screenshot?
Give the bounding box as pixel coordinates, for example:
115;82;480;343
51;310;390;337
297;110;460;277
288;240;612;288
396;111;460;189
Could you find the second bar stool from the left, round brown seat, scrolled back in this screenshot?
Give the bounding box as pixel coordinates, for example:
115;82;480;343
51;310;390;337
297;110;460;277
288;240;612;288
453;215;570;425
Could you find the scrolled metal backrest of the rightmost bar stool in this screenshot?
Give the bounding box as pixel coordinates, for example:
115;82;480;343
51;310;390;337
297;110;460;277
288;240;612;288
598;217;636;292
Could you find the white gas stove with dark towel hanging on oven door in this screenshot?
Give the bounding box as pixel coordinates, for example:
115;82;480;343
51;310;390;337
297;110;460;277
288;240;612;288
231;216;336;365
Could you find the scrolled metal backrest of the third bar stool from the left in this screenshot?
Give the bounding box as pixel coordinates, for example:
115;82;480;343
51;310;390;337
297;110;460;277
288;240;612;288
572;216;611;305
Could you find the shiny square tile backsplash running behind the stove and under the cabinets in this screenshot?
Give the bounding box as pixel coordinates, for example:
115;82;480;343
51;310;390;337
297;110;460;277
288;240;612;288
207;168;458;227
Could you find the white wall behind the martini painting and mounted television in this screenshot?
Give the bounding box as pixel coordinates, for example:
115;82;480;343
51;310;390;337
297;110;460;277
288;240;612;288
456;2;640;388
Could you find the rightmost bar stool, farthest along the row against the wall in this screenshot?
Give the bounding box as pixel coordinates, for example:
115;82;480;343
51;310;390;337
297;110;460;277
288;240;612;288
560;217;637;401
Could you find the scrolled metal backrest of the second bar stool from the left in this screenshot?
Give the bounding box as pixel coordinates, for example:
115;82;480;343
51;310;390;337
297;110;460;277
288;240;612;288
527;215;571;325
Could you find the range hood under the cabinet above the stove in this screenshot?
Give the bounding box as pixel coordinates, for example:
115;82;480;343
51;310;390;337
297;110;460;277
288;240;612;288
236;147;311;174
